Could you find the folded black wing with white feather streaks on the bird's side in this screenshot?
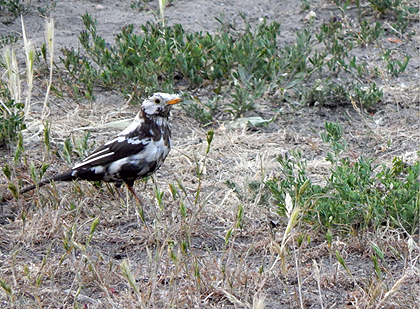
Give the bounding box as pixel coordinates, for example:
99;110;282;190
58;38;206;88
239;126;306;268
73;135;151;170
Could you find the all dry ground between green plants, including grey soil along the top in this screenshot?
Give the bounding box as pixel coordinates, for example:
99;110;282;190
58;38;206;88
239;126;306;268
0;0;420;308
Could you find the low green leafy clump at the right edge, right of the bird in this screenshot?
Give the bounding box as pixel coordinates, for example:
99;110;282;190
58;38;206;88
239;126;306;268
266;123;420;234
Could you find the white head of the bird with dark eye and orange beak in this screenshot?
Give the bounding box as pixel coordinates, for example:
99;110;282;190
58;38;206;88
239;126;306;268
142;92;182;117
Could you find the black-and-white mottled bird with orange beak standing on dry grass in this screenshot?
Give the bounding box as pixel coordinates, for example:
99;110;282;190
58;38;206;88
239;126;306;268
19;92;182;204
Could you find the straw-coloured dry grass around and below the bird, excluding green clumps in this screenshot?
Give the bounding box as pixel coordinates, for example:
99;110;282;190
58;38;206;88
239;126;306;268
0;1;420;309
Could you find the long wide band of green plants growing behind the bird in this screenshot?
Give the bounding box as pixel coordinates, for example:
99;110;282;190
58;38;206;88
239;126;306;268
61;0;416;123
